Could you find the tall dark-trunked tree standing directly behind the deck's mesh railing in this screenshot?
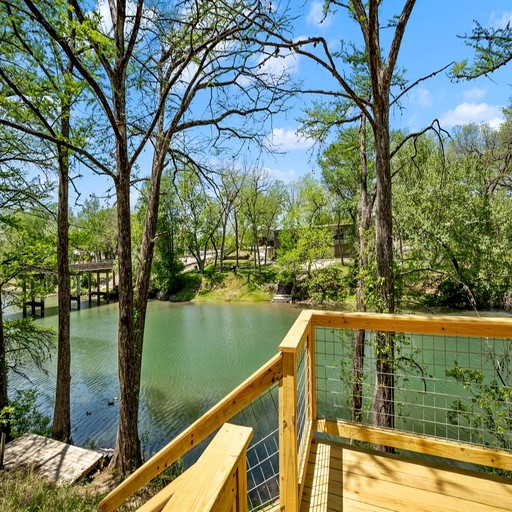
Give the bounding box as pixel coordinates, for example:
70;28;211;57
260;0;428;427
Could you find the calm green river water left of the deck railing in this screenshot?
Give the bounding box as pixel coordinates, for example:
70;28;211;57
10;301;300;455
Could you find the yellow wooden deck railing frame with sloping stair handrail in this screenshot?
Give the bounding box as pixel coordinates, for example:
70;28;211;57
100;311;512;512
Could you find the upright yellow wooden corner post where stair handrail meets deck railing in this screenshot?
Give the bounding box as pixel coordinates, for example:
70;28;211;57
279;351;299;512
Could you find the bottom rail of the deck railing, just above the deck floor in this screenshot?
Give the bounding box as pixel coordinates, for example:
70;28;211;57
317;419;512;471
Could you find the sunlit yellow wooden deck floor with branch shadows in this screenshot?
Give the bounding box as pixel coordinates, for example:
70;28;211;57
298;441;512;512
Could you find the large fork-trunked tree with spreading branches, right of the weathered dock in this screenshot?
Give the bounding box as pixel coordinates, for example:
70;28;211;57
0;0;285;473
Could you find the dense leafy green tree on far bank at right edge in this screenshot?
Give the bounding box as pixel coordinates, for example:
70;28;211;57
395;126;512;308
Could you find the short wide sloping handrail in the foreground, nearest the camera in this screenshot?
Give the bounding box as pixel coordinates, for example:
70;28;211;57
163;423;253;512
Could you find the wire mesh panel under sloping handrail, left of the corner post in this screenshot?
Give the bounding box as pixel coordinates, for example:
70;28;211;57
229;384;279;511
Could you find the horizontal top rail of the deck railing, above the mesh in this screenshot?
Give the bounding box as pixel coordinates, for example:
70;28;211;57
310;311;512;338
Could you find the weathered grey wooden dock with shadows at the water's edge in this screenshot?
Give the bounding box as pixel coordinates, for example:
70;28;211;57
4;434;103;484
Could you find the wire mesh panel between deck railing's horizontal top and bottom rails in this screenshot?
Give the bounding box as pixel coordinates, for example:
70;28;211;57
316;327;512;450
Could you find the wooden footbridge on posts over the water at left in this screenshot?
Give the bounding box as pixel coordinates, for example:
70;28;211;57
23;260;116;318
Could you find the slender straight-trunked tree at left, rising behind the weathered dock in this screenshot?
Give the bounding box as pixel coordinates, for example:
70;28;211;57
0;2;90;441
